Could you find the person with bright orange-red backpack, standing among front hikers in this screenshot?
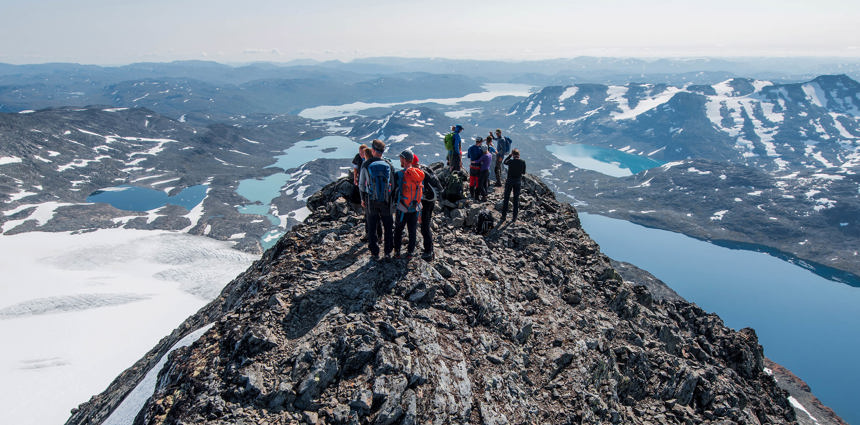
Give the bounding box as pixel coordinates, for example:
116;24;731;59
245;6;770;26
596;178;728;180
394;150;424;260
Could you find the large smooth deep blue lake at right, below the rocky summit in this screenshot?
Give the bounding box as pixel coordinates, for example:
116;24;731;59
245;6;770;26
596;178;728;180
580;213;860;423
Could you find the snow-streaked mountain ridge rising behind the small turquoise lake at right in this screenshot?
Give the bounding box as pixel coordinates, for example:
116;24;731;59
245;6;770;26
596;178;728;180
509;75;860;172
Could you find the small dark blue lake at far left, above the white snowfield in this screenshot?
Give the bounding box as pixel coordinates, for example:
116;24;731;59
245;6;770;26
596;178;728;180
87;185;208;211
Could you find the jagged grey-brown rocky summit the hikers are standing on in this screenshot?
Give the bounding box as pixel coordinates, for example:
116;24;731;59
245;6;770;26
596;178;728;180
68;165;796;424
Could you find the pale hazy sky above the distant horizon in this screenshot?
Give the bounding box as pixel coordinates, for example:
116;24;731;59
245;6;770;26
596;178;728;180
0;0;860;65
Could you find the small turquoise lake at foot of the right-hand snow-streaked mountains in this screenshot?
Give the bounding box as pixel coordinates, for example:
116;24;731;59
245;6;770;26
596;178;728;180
546;143;663;177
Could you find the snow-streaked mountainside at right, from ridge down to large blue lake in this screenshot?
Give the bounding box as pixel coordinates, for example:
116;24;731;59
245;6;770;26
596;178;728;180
508;75;860;282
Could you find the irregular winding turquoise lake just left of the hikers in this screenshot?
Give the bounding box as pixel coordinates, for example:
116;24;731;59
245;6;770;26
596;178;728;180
236;136;359;249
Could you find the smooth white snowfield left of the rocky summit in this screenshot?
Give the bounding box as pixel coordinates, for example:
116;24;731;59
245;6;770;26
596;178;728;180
0;229;257;425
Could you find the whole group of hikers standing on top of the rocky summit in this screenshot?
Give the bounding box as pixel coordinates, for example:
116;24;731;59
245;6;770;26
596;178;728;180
352;125;526;261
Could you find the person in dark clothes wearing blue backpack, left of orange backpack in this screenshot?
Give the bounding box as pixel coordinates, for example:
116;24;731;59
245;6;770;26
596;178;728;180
358;139;394;260
